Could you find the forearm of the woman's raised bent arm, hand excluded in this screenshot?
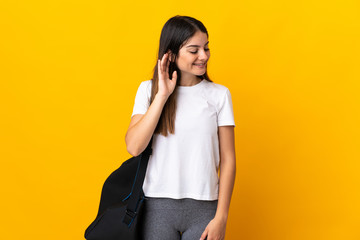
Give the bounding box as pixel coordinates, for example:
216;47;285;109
125;95;167;156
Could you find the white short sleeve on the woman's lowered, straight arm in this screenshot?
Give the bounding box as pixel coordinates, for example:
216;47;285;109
218;88;235;127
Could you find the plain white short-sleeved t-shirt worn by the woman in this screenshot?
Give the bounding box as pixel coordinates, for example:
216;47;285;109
131;80;235;200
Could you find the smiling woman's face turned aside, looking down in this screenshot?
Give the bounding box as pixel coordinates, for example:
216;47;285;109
176;31;210;78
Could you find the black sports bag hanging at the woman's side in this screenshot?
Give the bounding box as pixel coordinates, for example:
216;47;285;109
85;138;152;240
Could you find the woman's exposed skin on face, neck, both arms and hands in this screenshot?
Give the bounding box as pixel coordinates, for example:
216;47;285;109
125;32;236;240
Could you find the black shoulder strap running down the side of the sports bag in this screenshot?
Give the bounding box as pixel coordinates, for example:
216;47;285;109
123;136;153;227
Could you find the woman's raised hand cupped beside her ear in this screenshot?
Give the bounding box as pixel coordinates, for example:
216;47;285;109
157;53;177;98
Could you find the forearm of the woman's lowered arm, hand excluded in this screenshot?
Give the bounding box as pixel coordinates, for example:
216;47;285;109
215;155;236;221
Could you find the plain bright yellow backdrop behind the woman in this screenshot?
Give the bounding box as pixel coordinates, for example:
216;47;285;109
0;0;360;240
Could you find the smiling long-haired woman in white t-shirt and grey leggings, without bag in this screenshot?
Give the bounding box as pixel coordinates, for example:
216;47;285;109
125;16;235;240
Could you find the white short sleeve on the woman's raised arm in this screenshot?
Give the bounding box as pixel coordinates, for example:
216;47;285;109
131;80;151;117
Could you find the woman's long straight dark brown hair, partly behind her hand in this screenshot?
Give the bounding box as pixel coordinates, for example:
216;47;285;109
150;15;212;136
